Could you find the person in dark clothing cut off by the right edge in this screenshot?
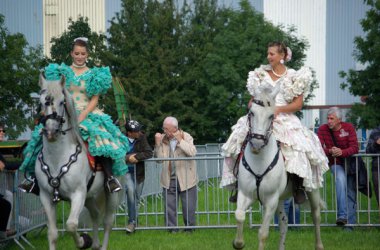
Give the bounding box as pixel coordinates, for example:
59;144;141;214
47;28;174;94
366;126;380;206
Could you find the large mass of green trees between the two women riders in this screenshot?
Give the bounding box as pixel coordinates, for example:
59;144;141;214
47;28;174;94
102;0;317;144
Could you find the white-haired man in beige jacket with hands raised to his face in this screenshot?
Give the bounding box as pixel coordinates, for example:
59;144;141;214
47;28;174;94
154;116;198;233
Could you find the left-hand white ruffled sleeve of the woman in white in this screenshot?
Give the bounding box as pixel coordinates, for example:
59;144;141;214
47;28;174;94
247;65;273;96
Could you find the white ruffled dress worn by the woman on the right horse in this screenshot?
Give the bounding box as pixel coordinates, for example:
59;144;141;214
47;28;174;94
220;65;329;191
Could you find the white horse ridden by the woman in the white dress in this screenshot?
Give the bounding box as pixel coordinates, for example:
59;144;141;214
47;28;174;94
233;89;323;250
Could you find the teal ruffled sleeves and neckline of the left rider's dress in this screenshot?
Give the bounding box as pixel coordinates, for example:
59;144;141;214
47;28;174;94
45;63;112;98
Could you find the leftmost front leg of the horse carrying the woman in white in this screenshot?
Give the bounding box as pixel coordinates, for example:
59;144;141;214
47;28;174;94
232;190;253;249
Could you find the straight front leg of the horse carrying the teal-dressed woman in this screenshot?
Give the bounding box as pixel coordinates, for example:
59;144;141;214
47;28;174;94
40;189;58;250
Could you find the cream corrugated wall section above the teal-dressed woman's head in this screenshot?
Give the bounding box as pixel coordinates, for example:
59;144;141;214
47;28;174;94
43;0;106;56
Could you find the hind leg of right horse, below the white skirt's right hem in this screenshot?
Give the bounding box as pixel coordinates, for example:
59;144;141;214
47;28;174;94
308;189;324;250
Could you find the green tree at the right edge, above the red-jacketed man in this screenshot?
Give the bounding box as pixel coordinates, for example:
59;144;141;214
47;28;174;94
340;0;380;128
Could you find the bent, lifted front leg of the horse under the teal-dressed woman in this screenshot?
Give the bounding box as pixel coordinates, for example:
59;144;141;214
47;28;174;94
66;191;87;248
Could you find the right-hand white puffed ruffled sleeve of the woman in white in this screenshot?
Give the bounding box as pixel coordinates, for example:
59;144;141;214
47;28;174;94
283;67;313;103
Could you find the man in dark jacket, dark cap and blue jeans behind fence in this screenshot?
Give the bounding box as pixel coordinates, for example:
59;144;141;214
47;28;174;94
125;120;153;233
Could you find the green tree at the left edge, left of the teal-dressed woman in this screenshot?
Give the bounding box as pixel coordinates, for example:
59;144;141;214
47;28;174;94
0;15;45;139
